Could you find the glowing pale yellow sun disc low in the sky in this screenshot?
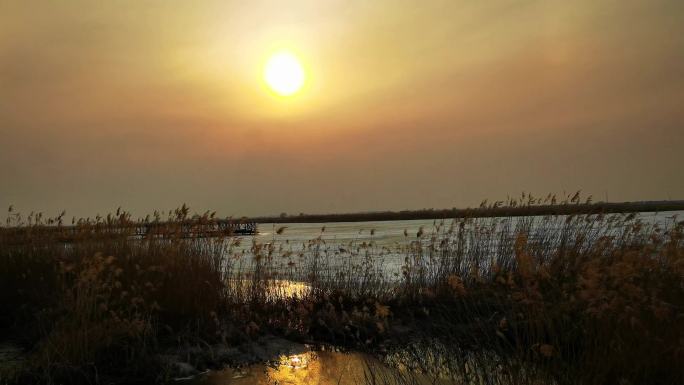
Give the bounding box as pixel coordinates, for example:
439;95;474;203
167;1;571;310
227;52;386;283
264;51;306;96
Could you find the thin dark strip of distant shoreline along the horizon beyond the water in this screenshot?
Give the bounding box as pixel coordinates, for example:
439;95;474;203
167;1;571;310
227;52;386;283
245;200;684;223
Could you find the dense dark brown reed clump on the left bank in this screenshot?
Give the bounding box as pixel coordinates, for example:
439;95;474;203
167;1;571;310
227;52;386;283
0;210;227;383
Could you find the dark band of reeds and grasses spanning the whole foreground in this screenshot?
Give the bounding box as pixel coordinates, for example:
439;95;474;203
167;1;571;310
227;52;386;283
0;198;684;384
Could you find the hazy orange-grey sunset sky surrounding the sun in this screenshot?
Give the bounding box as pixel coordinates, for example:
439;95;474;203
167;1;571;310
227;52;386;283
0;0;684;216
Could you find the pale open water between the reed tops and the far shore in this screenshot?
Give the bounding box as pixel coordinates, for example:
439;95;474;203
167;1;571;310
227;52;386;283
223;211;684;279
